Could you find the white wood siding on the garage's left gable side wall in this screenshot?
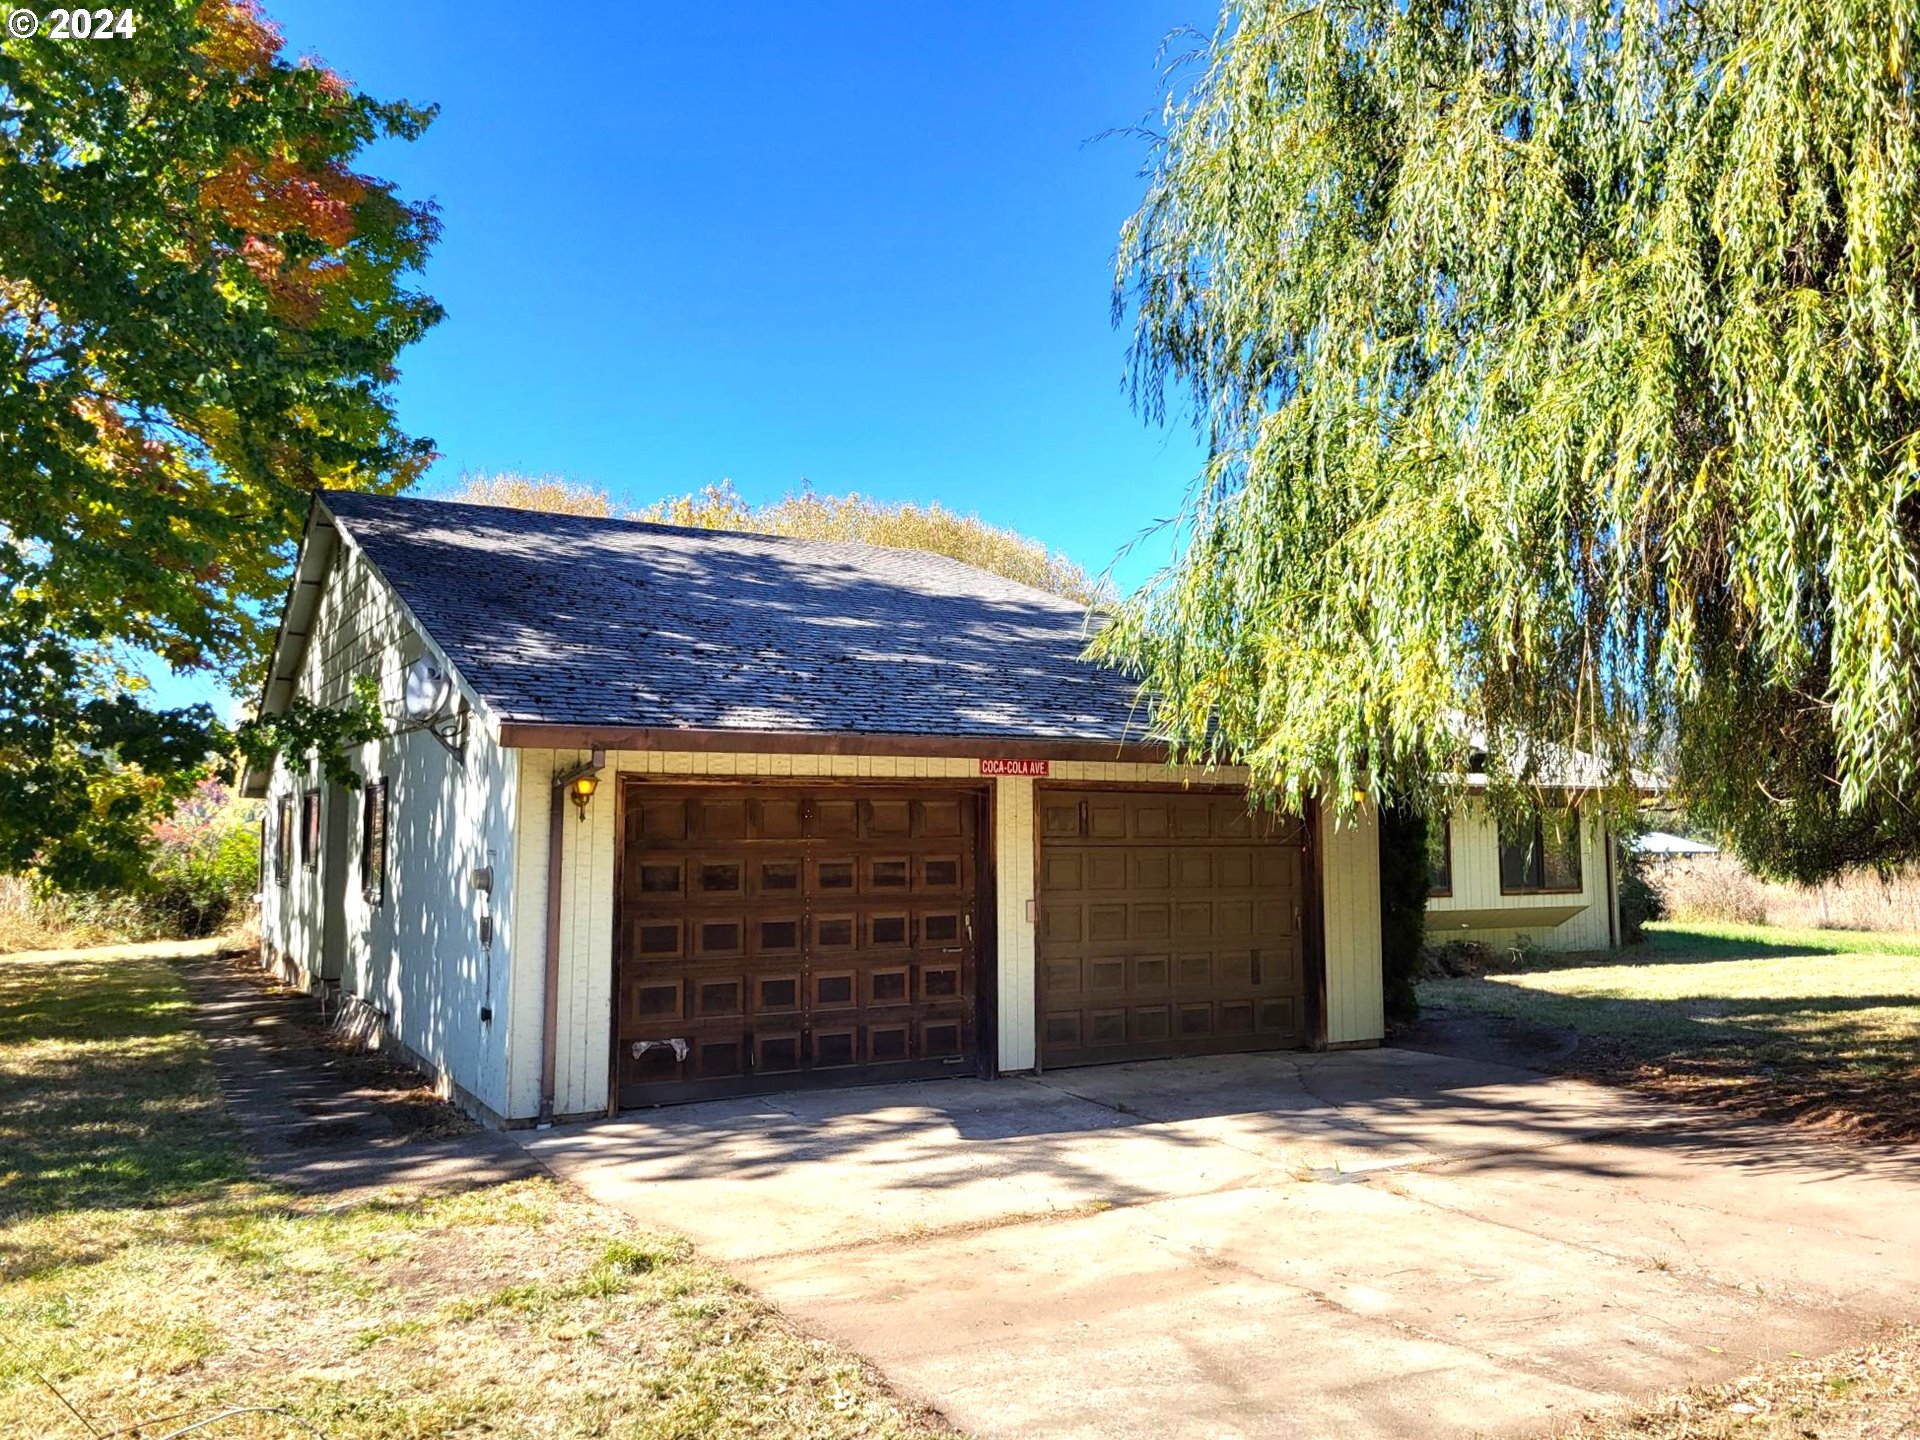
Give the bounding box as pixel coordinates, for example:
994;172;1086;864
261;543;518;1116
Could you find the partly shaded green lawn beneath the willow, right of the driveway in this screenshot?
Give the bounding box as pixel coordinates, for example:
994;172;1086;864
1421;924;1920;1139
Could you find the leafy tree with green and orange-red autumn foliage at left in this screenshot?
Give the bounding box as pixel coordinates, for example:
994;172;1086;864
0;0;440;883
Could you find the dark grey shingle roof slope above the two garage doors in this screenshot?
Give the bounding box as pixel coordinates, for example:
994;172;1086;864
323;492;1144;743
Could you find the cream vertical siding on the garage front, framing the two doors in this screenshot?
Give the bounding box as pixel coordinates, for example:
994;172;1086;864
533;751;1384;1117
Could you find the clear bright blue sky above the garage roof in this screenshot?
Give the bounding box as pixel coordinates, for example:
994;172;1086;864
157;0;1213;718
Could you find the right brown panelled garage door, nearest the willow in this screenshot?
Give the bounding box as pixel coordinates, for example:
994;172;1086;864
1037;789;1308;1066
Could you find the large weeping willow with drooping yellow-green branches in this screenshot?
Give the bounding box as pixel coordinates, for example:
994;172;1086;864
1102;0;1920;876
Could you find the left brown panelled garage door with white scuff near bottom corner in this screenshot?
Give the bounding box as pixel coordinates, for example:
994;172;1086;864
614;780;977;1104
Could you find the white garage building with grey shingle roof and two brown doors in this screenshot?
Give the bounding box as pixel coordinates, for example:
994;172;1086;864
246;493;1605;1125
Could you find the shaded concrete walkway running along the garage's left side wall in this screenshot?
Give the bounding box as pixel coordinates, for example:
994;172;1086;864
178;947;543;1202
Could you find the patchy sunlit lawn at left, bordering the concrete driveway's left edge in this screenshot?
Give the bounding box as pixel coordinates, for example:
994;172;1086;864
0;958;945;1440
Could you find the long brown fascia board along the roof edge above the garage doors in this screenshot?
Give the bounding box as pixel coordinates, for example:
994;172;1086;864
499;720;1169;764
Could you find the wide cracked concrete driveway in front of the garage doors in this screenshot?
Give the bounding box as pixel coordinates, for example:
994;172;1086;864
524;1050;1920;1440
